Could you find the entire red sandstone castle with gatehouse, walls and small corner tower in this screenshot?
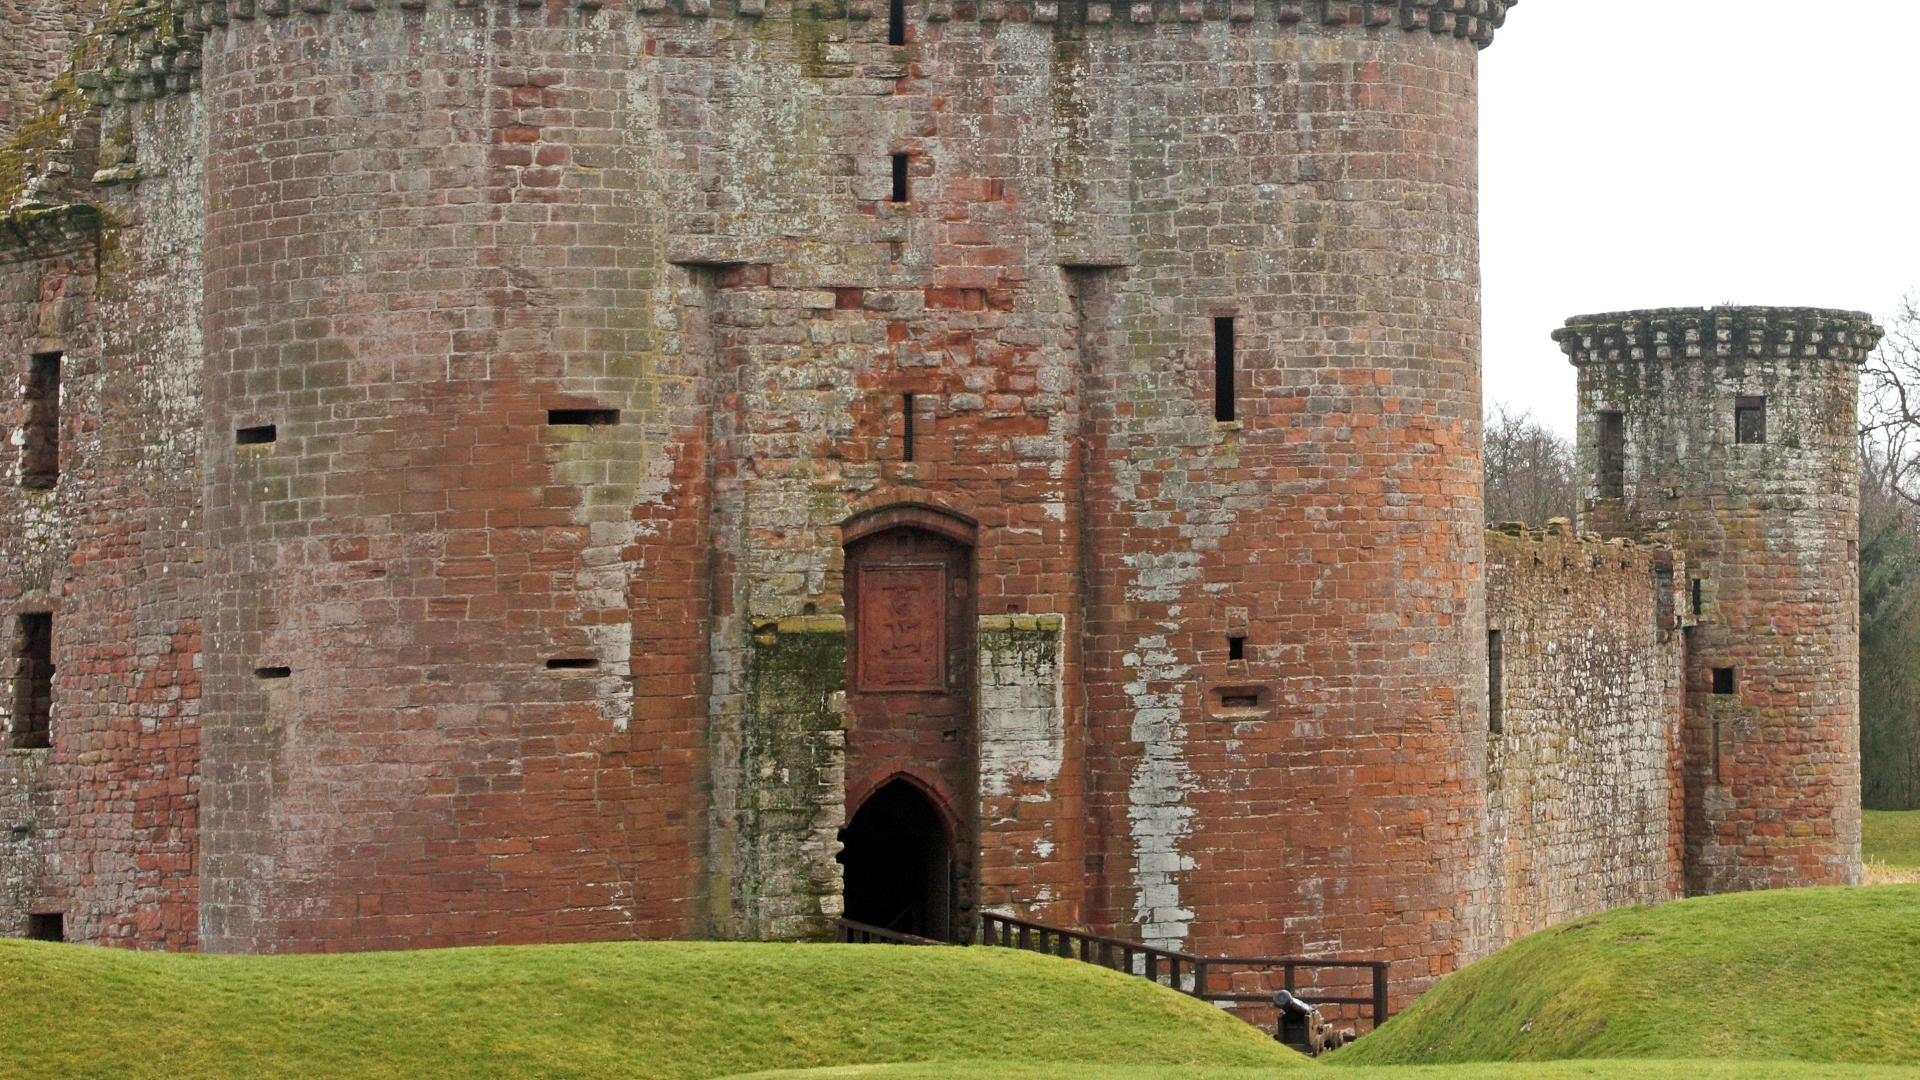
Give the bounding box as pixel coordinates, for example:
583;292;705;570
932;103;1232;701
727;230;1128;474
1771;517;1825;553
0;0;1880;1005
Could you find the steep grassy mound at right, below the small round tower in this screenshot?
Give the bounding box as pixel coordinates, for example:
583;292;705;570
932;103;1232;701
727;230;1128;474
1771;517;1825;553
1331;886;1920;1065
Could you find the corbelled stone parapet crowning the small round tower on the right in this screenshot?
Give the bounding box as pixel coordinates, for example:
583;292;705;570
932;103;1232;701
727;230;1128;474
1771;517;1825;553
1553;307;1885;365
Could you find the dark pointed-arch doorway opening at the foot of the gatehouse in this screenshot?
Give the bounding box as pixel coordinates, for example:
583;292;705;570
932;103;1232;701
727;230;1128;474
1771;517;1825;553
839;780;954;942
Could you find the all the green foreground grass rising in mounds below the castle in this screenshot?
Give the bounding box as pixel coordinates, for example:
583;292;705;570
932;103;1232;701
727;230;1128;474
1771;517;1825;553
15;886;1920;1080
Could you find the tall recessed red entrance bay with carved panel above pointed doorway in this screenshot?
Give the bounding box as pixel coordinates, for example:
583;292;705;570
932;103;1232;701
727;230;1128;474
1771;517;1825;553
841;511;975;940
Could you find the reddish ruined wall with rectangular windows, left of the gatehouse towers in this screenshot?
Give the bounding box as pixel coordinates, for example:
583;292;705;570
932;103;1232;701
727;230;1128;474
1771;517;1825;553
0;84;205;949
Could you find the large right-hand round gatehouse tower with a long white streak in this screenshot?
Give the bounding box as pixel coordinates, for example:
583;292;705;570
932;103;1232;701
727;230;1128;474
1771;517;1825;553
1077;14;1492;999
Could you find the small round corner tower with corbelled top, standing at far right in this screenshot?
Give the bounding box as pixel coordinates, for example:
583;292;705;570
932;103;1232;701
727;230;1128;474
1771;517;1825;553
1553;307;1882;894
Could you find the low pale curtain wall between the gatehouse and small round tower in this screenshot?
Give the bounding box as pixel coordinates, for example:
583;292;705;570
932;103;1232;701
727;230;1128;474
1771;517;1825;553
1486;523;1686;942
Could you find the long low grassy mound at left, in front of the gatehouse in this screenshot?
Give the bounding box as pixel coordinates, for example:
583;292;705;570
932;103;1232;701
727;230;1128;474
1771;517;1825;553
0;940;1306;1080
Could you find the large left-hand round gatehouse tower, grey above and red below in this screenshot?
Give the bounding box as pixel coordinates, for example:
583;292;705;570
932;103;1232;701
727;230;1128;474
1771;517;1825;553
200;4;660;951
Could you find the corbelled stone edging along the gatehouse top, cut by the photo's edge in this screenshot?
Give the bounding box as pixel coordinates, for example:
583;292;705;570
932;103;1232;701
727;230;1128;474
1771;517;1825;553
77;0;1519;106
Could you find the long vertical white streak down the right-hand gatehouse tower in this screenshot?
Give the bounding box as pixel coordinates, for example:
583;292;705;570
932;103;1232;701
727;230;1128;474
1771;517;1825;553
1121;552;1200;949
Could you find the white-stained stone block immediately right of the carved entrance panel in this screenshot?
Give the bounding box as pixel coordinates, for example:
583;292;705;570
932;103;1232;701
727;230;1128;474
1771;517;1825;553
979;615;1066;799
